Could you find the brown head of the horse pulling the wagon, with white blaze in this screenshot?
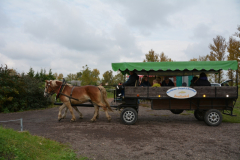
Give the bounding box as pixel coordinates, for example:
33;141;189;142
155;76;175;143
44;80;62;97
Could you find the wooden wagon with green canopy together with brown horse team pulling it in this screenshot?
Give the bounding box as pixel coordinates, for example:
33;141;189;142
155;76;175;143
44;61;238;126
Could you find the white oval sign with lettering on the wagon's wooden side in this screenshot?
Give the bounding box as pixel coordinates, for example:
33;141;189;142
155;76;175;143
166;87;197;99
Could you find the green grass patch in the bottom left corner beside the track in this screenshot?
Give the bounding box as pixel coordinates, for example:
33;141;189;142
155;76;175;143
0;126;88;160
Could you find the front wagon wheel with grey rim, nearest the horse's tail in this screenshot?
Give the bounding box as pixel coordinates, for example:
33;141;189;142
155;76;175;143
120;108;138;125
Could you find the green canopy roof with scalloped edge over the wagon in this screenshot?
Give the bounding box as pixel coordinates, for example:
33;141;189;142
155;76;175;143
112;61;238;75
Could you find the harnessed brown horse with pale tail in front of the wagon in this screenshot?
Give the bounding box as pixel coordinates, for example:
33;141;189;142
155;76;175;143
44;80;112;122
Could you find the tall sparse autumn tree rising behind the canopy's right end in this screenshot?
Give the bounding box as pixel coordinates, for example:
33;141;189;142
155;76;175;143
209;35;227;83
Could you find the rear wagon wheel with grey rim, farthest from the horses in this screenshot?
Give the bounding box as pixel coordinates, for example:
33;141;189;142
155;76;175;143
204;109;222;126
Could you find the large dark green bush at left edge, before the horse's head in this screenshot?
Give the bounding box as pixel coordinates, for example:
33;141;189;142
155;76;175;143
0;66;50;112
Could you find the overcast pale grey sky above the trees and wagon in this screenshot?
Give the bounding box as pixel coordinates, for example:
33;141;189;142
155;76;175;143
0;0;240;77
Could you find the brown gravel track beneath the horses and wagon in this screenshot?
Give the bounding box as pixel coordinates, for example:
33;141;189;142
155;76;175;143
0;99;240;160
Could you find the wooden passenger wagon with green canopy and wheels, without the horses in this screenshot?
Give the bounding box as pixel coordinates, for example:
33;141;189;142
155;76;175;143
112;61;238;126
